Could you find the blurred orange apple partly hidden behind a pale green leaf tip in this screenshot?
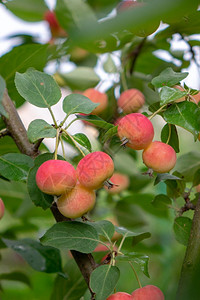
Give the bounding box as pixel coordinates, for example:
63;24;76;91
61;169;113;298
83;88;108;115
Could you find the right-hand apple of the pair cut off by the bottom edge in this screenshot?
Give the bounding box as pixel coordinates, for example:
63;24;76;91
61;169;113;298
132;285;165;300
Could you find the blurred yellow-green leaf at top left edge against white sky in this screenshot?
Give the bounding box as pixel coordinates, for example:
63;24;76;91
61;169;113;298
5;0;48;22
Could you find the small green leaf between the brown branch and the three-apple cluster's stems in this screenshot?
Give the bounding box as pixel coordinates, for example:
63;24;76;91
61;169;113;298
27;119;56;143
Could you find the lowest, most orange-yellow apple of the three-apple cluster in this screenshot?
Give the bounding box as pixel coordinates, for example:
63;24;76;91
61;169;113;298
57;183;96;219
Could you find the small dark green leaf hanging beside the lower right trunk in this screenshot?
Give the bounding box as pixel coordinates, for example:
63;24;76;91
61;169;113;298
173;217;192;246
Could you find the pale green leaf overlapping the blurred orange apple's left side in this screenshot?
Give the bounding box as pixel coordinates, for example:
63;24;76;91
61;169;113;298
63;94;99;116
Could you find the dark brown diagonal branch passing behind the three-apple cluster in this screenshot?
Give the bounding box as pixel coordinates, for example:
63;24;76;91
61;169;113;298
2;91;96;299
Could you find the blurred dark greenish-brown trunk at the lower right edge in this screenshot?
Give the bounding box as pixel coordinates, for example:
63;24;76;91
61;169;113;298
176;197;200;300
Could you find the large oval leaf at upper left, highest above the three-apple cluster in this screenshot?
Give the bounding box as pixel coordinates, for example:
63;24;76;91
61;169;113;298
15;69;61;108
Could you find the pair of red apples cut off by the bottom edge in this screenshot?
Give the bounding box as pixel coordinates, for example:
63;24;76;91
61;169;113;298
107;285;165;300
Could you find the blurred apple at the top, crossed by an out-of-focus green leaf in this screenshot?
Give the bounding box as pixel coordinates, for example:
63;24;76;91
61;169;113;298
117;0;160;37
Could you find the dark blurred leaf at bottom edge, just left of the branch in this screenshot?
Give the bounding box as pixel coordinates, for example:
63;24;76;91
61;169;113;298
51;259;87;300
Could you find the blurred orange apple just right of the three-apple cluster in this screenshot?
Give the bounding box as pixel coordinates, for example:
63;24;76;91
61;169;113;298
105;172;130;194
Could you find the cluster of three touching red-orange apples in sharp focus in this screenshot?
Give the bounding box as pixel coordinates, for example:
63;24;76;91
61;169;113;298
36;151;114;219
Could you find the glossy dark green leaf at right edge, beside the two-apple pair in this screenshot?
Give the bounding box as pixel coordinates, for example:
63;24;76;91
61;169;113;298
163;101;200;138
